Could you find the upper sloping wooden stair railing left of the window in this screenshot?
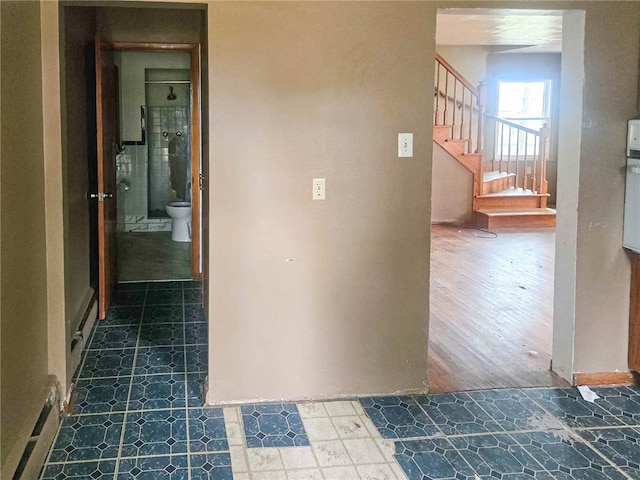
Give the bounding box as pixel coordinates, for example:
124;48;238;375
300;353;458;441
434;53;485;153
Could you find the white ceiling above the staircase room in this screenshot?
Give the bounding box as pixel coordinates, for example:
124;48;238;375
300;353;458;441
436;9;562;52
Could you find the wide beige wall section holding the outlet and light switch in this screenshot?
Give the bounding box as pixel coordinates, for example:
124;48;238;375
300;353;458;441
209;2;435;402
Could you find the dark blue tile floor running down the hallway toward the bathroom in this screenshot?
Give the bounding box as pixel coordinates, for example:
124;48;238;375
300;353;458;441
41;282;232;480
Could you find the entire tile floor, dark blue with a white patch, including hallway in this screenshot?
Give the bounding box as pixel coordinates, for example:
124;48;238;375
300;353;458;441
41;281;640;480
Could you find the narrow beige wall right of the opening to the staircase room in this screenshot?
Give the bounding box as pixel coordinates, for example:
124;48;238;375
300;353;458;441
572;2;640;372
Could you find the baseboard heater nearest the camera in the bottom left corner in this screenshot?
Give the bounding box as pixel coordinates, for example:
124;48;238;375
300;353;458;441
10;377;60;480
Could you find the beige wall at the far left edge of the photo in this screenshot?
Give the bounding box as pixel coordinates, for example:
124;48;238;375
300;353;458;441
0;1;48;478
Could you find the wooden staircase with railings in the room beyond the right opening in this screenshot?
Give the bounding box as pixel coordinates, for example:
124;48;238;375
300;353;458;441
433;54;556;228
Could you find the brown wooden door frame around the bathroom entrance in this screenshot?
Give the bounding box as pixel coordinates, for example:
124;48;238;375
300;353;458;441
110;42;202;280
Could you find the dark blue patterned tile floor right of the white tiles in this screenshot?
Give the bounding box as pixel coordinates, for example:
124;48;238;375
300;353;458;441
360;386;640;480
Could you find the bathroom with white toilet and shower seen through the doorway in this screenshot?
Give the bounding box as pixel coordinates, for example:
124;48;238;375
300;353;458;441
115;51;193;282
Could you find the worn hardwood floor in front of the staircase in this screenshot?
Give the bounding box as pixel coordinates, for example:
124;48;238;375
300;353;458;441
429;225;568;392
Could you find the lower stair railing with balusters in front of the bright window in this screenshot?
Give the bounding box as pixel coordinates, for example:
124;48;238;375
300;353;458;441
485;114;549;202
